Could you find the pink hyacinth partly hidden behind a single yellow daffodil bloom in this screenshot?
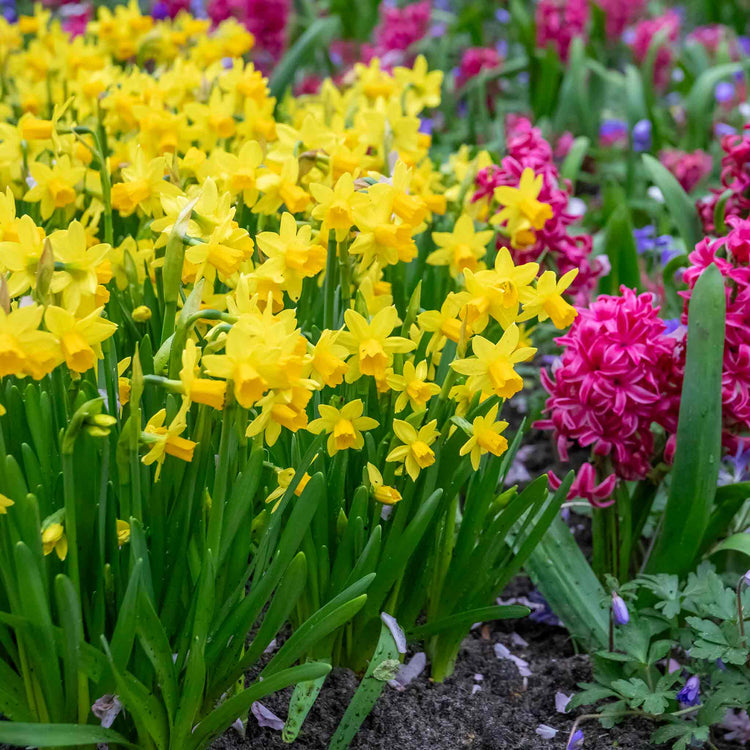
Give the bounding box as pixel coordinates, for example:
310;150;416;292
472;115;606;304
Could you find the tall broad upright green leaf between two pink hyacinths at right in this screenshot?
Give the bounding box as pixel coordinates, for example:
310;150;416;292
646;264;725;574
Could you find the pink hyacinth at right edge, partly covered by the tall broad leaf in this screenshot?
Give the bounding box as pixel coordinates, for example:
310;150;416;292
681;223;750;452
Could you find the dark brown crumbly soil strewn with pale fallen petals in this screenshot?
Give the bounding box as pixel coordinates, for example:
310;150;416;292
212;620;651;750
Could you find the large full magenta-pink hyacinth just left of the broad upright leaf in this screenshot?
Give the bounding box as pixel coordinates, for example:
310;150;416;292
536;287;681;486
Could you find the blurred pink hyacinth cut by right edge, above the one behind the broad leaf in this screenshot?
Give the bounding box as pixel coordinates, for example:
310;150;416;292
696;127;750;234
